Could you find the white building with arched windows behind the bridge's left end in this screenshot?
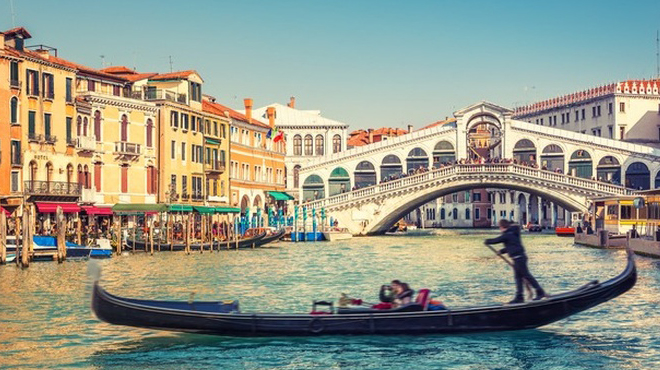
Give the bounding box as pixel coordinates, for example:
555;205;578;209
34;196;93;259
253;97;350;197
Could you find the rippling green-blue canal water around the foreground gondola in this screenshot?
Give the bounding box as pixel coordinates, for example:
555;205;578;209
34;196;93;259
0;231;660;369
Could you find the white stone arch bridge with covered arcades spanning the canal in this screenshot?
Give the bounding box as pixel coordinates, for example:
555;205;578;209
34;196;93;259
299;102;660;234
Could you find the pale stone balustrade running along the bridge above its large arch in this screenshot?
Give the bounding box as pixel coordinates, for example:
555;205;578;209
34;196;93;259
302;163;634;210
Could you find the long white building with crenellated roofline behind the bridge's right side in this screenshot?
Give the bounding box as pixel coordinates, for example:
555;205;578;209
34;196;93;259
513;80;660;144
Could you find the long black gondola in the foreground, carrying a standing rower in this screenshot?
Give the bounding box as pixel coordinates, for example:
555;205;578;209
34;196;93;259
92;250;637;336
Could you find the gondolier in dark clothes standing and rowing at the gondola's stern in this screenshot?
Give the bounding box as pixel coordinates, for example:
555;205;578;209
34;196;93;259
484;219;546;304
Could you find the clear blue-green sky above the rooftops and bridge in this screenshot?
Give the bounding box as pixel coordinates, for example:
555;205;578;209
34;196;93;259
0;0;660;129
